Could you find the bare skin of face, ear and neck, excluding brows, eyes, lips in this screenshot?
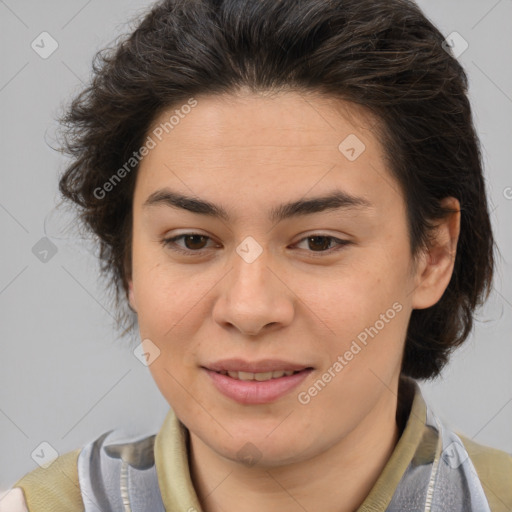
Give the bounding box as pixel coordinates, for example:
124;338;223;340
129;91;460;512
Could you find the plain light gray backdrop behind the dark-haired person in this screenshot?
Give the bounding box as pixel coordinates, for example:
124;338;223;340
0;0;512;490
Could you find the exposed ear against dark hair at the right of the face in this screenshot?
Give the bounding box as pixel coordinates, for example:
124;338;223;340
412;197;460;309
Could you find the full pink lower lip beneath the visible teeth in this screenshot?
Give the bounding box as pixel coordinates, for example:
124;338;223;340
204;368;313;405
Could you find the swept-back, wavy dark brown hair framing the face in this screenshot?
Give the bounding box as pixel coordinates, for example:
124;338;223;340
60;0;494;378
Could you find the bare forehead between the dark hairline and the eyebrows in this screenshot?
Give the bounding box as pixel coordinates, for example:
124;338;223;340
136;92;399;218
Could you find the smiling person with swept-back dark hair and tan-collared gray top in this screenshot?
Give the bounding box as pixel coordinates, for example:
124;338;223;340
4;0;512;512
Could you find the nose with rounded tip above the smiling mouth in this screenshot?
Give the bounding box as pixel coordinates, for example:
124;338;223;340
213;247;295;336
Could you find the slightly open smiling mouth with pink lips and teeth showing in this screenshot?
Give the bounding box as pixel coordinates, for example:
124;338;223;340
202;360;314;405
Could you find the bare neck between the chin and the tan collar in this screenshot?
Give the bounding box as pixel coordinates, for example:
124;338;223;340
189;393;401;512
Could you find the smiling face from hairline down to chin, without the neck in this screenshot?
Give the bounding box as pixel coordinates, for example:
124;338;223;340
129;92;452;465
